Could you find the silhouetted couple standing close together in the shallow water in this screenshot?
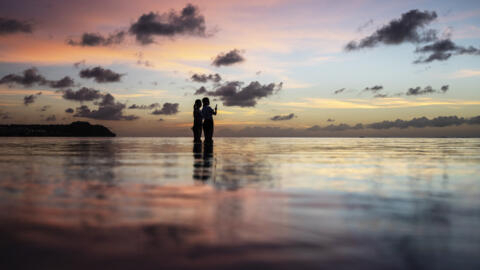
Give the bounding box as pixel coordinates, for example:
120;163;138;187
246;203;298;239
192;97;217;143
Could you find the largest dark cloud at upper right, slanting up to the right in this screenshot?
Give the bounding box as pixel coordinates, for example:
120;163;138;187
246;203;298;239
345;9;437;51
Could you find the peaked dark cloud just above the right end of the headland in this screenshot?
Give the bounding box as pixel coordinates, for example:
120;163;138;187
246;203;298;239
73;94;139;121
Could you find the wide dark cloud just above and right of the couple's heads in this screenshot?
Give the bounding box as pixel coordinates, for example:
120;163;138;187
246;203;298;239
195;81;283;107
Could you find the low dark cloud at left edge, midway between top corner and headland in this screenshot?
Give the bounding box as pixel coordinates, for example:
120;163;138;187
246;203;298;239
0;67;75;88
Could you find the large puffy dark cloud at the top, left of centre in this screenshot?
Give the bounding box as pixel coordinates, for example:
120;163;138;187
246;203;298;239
129;4;207;45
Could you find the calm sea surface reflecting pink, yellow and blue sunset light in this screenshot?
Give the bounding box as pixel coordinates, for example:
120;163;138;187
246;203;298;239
0;138;480;270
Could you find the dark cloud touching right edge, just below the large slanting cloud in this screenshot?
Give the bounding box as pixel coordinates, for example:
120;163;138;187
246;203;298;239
413;38;480;64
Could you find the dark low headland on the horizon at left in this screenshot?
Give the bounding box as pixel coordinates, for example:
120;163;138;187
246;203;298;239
0;121;116;137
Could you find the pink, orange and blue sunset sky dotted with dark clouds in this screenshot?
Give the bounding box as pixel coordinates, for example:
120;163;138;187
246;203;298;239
0;0;480;136
